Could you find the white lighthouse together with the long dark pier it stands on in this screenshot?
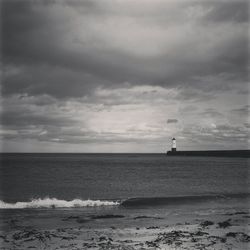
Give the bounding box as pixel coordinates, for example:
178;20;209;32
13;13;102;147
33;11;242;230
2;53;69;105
167;138;250;158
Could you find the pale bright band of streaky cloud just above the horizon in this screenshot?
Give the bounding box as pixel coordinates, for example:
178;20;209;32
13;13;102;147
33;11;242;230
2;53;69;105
1;86;247;149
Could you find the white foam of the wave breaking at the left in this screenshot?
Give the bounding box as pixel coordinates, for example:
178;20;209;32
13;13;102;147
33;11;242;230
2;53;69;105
0;198;119;209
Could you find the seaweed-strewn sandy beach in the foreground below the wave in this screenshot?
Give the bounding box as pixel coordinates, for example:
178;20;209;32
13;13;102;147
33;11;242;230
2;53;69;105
0;201;250;250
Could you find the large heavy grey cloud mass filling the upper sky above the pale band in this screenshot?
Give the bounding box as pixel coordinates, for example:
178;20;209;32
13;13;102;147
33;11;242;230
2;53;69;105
2;1;248;98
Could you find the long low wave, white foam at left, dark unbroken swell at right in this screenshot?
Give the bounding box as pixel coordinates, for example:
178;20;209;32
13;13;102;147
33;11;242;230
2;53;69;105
0;193;250;209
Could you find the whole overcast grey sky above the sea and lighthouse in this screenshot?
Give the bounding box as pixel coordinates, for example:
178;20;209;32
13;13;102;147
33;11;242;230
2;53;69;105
0;0;250;153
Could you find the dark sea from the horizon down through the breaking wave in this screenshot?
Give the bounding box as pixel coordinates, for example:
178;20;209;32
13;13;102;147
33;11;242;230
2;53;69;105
0;153;250;209
